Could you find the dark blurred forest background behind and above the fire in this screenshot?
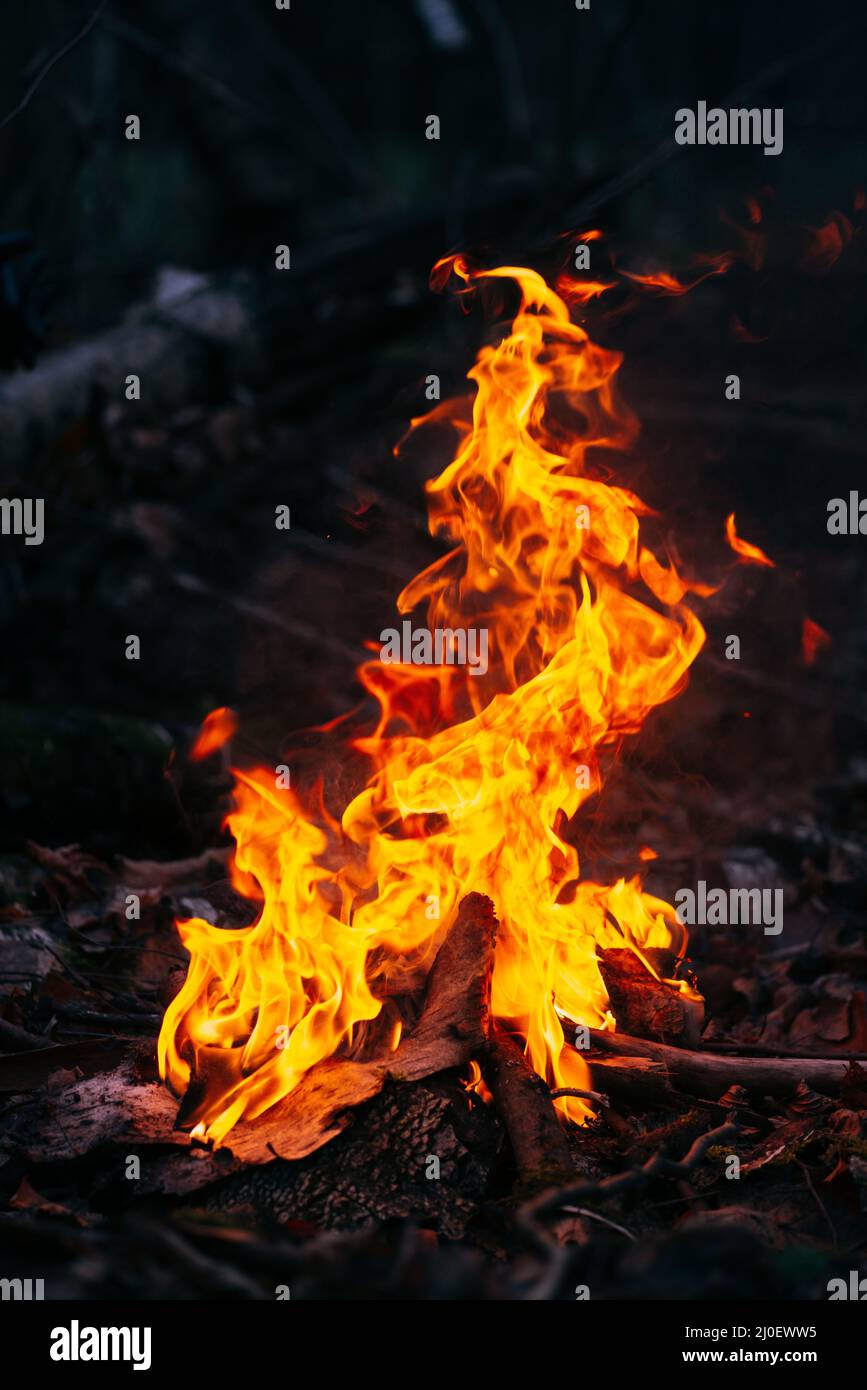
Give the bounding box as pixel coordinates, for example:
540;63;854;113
0;0;867;852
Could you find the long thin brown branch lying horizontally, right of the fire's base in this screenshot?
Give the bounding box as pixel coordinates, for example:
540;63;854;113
582;1029;849;1099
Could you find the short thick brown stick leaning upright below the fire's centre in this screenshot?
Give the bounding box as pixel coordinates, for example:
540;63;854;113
484;1031;574;1186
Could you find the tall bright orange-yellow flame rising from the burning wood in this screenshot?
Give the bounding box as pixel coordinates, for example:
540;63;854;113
158;257;711;1141
